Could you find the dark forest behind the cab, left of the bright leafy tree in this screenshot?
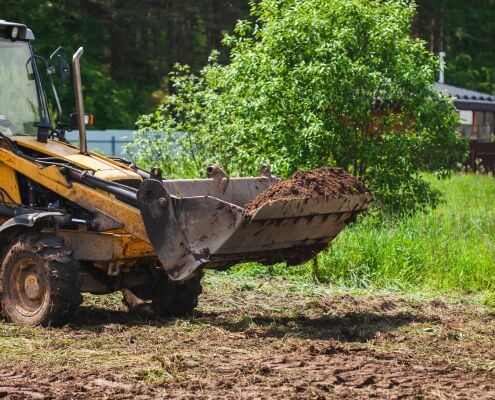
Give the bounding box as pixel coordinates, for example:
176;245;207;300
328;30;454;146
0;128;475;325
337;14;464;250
0;0;248;129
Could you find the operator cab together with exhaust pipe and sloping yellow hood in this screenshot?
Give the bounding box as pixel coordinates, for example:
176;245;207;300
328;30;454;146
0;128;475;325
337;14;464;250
0;20;143;187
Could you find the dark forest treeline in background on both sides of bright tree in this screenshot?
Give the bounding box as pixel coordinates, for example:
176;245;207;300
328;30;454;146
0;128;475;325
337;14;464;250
0;0;495;129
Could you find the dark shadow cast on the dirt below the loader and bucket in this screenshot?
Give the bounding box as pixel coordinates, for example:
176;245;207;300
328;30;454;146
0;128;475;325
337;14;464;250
70;307;438;342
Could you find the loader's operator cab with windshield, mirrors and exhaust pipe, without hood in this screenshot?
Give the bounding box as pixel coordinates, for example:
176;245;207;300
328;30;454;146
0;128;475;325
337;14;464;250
0;20;84;146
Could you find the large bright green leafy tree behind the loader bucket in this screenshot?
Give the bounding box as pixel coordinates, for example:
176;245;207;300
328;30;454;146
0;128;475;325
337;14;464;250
129;0;465;216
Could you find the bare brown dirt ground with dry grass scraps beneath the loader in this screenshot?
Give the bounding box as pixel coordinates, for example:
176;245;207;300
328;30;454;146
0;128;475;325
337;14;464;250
0;275;495;399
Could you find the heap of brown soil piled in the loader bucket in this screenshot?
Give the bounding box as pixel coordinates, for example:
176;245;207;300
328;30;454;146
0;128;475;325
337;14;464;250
244;167;369;212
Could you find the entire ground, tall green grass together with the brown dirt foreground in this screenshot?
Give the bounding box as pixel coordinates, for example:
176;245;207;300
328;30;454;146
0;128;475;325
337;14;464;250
0;175;495;400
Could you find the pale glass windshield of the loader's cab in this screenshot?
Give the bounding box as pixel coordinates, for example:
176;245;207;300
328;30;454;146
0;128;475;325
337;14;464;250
0;39;40;135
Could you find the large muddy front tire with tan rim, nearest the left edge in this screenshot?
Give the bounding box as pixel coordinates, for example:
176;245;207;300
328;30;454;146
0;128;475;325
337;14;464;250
0;234;82;326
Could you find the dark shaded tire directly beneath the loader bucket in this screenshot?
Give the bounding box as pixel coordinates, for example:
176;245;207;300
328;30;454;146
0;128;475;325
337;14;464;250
123;271;203;317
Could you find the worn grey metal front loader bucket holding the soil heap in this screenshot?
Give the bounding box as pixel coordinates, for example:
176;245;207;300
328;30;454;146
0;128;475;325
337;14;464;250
138;177;372;280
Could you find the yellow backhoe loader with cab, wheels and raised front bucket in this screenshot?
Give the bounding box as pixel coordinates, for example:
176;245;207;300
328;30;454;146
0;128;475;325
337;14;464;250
0;20;371;325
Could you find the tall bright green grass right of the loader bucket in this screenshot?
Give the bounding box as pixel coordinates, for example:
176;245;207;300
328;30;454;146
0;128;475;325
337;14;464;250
234;174;495;296
